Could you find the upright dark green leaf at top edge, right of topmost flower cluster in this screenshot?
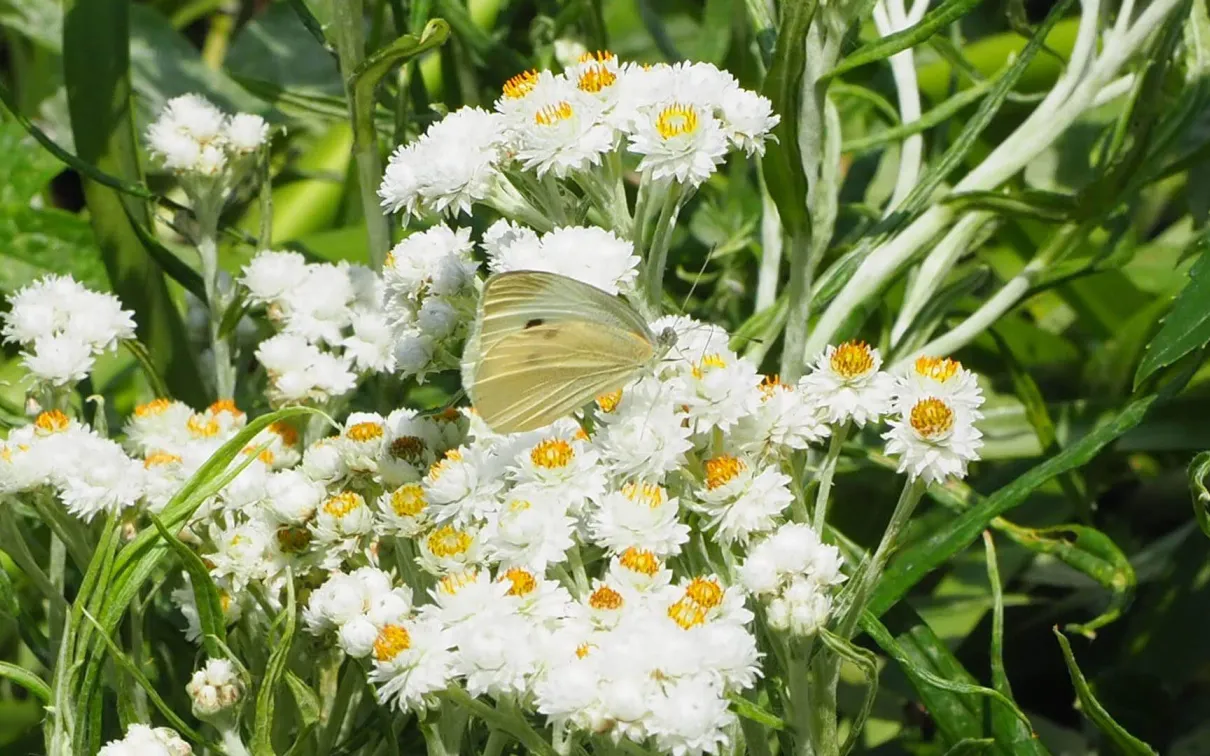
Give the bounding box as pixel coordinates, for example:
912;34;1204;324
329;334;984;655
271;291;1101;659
761;0;818;237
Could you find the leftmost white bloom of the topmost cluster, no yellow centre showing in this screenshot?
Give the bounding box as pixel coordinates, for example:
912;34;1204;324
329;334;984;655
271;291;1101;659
379;108;505;215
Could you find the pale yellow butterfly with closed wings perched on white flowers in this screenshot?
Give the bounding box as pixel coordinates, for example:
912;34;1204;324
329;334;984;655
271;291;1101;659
462;271;676;433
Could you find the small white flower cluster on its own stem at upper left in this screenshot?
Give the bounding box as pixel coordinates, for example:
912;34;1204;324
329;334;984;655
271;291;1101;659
146;94;269;179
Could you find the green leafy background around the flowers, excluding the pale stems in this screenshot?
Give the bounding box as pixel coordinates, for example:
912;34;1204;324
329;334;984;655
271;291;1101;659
0;0;1210;755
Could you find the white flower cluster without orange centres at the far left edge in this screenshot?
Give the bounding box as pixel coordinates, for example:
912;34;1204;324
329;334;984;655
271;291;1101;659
0;276;134;388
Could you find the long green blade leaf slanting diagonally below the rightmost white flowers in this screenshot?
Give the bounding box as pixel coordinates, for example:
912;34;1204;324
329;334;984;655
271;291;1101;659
870;394;1158;616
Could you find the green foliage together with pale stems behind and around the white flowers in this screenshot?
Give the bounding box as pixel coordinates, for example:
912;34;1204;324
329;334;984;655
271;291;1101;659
0;0;1210;754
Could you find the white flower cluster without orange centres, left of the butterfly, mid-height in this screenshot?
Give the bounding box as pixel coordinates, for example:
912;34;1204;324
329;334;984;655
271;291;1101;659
240;250;394;405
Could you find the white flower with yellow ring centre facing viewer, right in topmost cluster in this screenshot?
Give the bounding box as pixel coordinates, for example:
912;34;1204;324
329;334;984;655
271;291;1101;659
629;100;727;186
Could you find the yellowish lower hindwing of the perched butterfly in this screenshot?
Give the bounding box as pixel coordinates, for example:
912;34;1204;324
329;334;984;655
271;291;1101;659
471;321;655;433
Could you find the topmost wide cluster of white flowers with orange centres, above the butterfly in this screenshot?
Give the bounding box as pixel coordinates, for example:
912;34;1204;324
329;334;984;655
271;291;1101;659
379;52;778;221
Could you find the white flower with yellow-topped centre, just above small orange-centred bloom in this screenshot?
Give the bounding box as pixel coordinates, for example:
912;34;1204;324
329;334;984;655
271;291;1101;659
588;481;688;558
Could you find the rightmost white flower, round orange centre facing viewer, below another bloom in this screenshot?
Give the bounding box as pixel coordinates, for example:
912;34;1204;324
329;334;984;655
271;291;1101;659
882;397;983;483
